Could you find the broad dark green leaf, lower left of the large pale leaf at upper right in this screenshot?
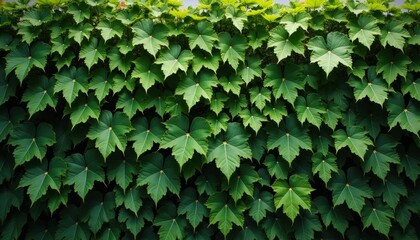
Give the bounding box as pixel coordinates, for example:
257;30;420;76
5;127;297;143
264;63;304;105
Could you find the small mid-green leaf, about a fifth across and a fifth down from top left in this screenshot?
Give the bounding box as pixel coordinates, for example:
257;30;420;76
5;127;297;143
79;37;106;70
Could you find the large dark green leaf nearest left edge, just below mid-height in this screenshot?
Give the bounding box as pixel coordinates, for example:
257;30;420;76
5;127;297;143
9;122;56;166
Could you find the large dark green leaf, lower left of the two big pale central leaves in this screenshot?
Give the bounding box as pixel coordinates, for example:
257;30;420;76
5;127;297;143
137;153;181;205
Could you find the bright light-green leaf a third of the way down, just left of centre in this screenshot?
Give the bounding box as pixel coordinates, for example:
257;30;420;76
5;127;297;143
175;70;217;110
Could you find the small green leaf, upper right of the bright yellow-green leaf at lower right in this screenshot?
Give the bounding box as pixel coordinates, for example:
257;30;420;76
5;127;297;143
312;152;338;185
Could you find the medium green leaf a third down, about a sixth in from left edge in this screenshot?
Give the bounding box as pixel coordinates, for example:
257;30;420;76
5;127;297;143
54;66;89;106
